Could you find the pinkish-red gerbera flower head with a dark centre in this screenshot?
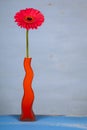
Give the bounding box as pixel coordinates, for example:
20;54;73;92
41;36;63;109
14;8;44;30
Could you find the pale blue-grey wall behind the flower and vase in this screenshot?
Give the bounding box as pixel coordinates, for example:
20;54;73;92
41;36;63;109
0;0;87;115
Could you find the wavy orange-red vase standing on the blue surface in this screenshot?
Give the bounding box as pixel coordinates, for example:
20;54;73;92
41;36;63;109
20;58;35;121
